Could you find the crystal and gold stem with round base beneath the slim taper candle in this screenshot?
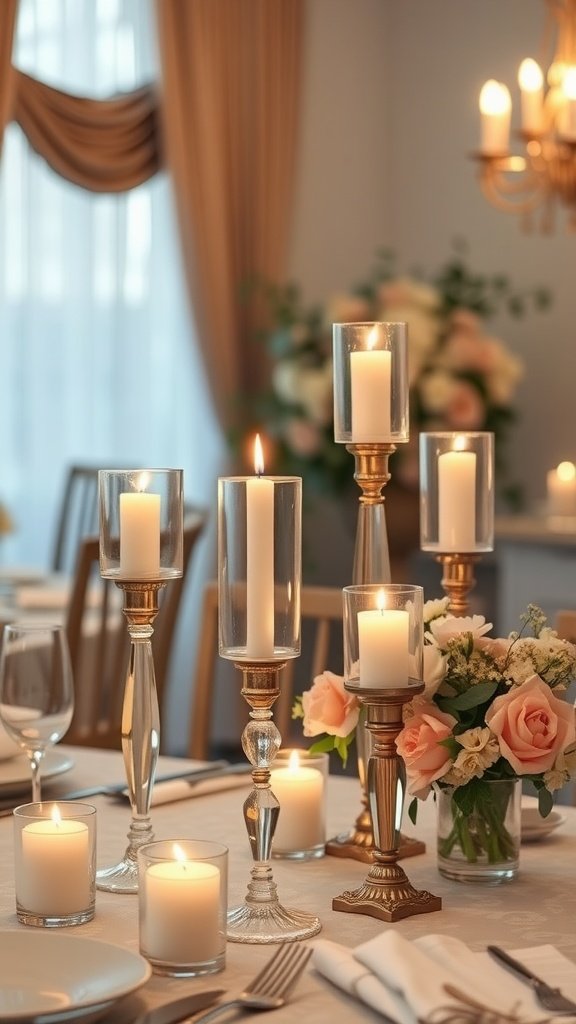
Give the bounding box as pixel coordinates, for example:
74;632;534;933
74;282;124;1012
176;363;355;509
228;662;321;943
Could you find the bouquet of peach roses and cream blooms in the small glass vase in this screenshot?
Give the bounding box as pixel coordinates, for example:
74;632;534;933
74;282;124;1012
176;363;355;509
397;598;576;815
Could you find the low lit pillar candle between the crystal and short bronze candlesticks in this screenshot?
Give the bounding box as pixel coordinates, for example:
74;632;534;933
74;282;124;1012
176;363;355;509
271;751;326;853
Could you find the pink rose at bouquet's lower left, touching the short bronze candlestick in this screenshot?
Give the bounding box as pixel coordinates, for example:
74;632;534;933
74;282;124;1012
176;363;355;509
396;703;456;800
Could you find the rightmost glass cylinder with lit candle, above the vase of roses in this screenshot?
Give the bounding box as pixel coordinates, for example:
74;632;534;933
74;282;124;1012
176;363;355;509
420;431;494;554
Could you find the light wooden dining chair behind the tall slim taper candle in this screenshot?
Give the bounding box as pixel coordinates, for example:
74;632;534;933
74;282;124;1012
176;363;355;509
187;581;342;760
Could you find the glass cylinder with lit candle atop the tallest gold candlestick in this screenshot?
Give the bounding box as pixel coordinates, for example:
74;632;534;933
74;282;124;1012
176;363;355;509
332;323;409;444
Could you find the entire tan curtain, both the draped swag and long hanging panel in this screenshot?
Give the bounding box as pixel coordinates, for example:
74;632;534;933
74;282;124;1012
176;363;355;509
0;0;304;426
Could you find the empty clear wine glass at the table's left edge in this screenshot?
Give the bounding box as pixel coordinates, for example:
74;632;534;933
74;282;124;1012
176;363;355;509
0;623;74;803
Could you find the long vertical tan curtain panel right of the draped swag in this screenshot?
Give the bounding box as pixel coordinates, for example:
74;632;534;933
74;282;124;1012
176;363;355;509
156;0;303;425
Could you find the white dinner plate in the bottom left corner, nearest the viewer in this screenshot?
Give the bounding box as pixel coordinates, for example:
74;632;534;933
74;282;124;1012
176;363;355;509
0;930;152;1024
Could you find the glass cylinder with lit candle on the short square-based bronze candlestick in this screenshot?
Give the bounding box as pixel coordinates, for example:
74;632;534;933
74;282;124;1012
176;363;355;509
343;584;424;689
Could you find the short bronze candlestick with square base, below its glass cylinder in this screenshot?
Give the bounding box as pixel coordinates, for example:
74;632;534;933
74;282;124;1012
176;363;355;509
332;683;442;922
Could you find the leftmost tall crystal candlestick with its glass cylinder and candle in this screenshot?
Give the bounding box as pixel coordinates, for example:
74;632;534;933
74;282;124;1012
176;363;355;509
96;469;183;893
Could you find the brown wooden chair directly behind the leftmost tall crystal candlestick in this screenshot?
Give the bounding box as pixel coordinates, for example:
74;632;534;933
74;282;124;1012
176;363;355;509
66;506;206;749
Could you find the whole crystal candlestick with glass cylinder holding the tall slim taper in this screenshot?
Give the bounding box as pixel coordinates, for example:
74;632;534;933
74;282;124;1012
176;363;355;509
218;475;320;942
